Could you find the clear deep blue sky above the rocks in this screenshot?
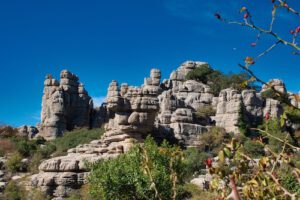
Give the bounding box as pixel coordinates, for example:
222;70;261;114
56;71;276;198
0;0;300;126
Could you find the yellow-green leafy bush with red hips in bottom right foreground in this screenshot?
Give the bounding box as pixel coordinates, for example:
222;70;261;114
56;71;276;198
207;118;300;200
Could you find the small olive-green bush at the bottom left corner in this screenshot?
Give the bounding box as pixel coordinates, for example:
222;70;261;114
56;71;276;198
4;181;26;200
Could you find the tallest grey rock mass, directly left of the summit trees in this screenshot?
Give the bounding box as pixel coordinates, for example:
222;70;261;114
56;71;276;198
156;61;213;146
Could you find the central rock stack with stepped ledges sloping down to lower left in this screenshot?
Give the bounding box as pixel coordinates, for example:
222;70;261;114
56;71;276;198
31;70;161;200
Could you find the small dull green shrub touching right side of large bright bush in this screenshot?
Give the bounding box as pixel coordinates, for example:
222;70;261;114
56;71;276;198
184;147;209;179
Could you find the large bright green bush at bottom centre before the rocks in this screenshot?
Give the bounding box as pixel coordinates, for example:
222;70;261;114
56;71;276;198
89;137;183;200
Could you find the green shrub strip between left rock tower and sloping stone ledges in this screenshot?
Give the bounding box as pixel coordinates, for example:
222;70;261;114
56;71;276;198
52;128;104;156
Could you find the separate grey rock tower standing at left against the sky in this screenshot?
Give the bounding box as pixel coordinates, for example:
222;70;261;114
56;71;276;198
39;70;93;139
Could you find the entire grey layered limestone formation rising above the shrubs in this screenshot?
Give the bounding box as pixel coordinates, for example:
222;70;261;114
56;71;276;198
32;61;298;199
